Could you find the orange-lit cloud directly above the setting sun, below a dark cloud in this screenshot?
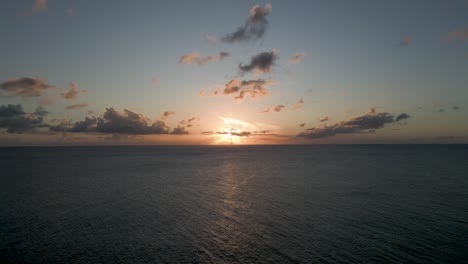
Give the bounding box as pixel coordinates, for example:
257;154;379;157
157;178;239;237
205;79;274;101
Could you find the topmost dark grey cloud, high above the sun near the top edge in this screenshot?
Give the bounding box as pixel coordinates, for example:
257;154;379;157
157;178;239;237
221;4;272;43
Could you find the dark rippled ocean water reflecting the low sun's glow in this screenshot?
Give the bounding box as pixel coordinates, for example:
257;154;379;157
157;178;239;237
0;145;468;263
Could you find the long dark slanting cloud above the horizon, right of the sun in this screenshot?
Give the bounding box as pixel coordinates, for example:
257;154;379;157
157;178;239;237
298;108;409;139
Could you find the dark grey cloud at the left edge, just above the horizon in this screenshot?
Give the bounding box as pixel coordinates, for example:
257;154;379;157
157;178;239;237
0;104;48;133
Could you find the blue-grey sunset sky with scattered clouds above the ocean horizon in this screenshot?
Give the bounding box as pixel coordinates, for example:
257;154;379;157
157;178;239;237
0;0;468;146
